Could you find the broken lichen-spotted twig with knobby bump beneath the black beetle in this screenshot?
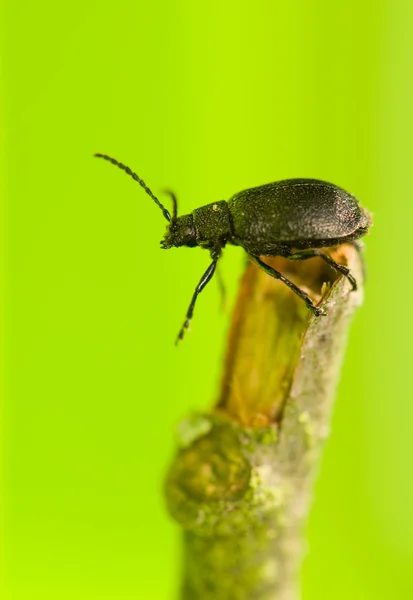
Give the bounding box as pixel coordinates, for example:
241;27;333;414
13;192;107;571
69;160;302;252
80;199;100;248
166;245;363;600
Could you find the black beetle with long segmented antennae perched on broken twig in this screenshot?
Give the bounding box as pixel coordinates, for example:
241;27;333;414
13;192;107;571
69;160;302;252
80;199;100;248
95;153;372;343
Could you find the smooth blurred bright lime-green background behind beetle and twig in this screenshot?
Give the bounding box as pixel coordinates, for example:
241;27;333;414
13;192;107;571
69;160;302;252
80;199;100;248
0;0;413;600
